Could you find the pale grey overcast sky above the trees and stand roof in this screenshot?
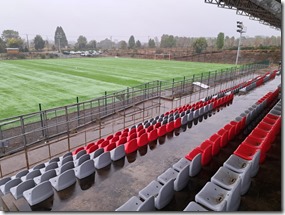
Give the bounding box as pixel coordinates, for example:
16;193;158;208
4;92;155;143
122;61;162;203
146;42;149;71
0;0;281;42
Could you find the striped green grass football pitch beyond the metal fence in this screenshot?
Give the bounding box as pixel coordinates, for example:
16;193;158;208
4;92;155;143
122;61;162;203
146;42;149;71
0;58;234;119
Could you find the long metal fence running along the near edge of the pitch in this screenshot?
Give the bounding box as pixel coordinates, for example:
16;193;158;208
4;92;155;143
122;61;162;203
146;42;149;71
0;61;267;157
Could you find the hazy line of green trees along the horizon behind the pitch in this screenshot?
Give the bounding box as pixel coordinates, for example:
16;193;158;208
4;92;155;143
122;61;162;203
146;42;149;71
0;26;281;53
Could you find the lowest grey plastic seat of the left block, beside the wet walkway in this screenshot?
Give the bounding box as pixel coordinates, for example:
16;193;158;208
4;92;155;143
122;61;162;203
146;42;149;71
23;181;53;206
